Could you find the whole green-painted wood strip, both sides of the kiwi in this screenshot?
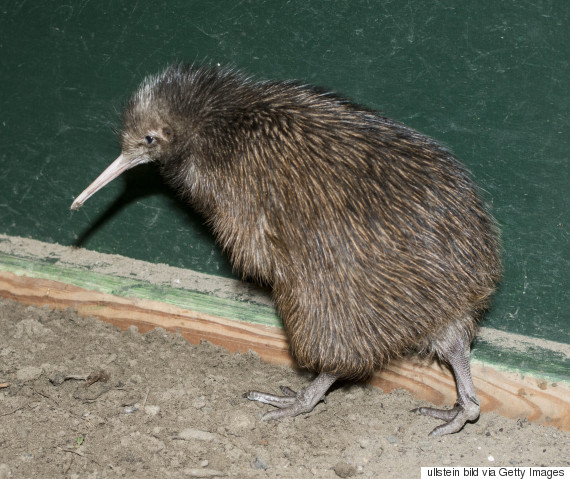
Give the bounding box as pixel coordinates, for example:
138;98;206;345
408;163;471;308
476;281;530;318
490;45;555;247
0;253;570;382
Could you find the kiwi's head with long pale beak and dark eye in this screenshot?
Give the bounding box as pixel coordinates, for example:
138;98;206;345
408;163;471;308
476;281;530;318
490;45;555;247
71;65;259;210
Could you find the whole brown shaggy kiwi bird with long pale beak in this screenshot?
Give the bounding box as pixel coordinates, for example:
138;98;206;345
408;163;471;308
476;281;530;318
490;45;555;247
71;65;501;435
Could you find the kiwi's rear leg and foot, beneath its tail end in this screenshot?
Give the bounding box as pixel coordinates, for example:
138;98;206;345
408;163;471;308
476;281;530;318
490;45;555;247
414;340;480;436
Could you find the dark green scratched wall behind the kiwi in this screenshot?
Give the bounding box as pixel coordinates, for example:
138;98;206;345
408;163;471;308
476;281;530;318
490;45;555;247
0;0;570;343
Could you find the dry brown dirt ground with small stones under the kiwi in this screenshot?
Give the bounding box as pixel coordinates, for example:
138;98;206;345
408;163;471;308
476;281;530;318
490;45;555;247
0;301;570;479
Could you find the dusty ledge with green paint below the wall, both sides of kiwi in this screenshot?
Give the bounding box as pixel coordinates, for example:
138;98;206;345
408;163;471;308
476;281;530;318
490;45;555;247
0;234;570;383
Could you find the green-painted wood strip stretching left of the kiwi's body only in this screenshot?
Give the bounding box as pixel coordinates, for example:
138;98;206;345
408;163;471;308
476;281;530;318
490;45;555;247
0;253;282;327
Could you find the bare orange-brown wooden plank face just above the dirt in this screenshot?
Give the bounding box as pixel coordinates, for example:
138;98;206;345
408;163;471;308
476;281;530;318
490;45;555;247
0;271;570;430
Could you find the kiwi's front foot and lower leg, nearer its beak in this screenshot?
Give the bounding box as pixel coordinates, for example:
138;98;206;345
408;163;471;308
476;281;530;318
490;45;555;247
243;373;338;421
